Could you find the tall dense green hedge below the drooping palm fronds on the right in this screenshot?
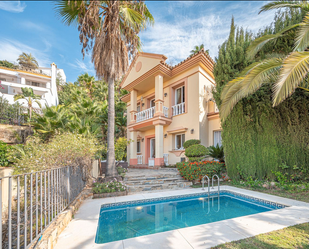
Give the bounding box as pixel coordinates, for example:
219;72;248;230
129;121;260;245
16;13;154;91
222;86;309;179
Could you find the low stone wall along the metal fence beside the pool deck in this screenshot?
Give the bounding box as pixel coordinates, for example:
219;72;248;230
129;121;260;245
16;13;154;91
34;188;92;249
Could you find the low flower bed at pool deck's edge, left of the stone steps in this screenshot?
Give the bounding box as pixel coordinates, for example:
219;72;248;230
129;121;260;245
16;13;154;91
92;180;127;198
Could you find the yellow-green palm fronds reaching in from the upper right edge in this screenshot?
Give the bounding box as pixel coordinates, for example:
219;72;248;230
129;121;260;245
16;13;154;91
220;1;309;120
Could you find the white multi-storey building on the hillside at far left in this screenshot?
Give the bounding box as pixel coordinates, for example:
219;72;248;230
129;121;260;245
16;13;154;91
0;63;58;108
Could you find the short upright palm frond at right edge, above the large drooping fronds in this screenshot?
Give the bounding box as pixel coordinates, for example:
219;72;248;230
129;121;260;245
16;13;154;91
294;13;309;51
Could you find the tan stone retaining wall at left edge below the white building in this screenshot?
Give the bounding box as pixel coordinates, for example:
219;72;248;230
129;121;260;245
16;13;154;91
0;124;33;144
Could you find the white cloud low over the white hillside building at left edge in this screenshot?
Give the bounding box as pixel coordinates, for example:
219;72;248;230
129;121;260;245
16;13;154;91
0;39;51;66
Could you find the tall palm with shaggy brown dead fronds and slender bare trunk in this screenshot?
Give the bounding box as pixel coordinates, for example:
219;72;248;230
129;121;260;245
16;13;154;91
56;0;154;177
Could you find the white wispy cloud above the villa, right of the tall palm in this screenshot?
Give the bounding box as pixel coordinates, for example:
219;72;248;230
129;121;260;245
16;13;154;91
141;2;274;64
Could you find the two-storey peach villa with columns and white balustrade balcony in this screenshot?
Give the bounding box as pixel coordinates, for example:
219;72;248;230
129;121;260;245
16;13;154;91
121;51;221;167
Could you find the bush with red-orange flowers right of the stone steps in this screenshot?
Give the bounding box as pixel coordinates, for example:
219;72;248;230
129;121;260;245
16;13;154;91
176;161;225;181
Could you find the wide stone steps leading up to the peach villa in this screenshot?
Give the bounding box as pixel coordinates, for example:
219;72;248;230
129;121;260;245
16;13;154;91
124;168;192;193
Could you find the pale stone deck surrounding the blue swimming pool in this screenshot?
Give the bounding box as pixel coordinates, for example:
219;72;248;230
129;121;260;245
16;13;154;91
55;186;309;249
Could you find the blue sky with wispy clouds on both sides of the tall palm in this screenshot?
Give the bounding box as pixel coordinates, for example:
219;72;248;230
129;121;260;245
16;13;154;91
0;0;274;82
